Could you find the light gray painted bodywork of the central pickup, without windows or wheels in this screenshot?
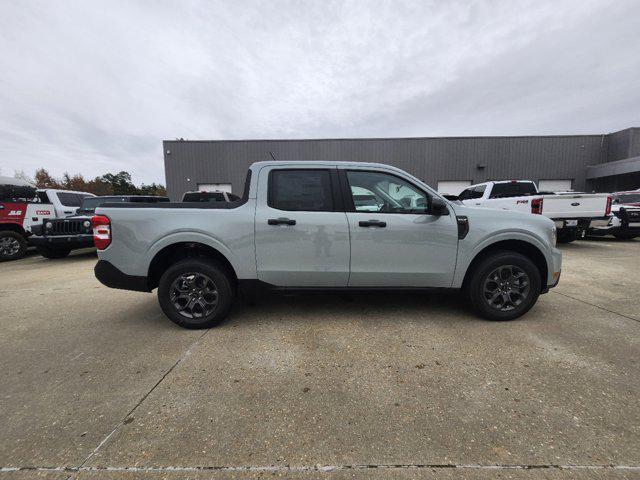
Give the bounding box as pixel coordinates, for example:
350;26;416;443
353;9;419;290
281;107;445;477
96;161;562;288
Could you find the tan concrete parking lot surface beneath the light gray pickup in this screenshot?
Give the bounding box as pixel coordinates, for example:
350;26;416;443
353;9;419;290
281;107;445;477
0;239;640;479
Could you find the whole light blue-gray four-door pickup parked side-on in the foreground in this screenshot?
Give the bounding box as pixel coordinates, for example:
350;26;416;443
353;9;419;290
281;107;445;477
92;161;562;328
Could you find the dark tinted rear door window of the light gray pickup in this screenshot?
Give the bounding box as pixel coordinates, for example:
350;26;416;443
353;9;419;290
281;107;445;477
268;169;333;212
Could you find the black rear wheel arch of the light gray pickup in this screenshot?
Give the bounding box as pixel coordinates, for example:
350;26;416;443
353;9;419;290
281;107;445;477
147;242;238;290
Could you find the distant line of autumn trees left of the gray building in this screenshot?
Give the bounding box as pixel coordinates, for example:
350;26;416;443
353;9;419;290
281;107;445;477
23;168;167;196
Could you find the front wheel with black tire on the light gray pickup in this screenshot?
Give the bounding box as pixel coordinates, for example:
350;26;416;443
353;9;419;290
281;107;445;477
465;251;541;320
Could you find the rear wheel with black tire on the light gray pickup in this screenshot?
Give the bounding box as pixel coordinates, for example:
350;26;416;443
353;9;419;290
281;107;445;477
158;258;235;329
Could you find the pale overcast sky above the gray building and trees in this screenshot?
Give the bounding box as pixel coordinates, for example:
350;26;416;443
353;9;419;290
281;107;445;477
0;0;640;183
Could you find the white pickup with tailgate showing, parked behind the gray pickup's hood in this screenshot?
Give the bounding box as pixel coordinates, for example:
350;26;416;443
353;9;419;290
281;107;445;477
458;180;612;243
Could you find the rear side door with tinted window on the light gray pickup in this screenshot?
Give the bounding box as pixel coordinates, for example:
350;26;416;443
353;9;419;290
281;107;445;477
255;166;350;287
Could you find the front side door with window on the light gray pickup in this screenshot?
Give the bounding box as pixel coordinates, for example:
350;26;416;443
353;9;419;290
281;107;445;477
340;169;458;287
